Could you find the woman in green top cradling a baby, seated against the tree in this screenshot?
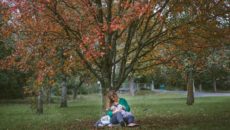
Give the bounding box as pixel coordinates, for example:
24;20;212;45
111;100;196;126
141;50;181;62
107;90;136;126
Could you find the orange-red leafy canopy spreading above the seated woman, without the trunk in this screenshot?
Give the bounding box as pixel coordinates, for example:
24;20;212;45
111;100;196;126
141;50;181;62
0;0;227;90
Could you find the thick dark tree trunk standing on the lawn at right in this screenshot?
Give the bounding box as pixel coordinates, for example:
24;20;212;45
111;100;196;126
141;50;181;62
187;71;194;105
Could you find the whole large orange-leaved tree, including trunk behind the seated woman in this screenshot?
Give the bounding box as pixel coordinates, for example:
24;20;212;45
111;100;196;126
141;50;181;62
0;0;227;108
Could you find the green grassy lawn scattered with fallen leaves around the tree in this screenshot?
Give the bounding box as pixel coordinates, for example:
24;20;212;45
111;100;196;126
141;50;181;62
0;92;230;130
